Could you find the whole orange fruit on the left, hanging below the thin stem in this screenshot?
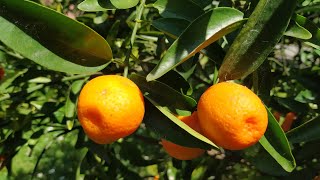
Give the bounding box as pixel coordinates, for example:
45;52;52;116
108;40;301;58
77;75;145;144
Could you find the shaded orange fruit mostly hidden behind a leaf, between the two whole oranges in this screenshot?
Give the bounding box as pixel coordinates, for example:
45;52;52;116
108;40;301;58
161;112;205;160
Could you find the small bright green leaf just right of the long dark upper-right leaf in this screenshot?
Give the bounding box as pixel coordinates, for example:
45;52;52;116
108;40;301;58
284;21;312;39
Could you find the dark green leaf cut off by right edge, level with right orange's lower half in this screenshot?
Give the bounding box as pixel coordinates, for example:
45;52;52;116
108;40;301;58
287;116;320;143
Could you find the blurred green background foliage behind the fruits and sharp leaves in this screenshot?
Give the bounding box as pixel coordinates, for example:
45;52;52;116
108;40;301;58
0;0;320;180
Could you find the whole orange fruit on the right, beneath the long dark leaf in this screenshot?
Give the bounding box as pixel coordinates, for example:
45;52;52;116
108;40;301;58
198;82;268;150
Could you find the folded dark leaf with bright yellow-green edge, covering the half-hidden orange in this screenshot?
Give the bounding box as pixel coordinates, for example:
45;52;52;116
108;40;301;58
143;95;218;149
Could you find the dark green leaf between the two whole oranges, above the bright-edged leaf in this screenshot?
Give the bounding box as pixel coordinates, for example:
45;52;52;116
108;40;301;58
129;74;197;114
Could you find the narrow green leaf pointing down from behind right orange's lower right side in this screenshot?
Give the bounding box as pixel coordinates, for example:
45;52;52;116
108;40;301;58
259;108;296;172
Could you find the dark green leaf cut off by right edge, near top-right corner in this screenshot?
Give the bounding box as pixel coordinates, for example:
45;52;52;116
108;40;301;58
292;14;320;49
